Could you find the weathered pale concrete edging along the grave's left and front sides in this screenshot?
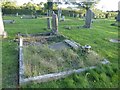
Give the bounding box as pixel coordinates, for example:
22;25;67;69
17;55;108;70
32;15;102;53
19;38;110;85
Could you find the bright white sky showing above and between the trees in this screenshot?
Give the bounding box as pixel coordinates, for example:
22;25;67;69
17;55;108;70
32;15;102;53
16;0;120;11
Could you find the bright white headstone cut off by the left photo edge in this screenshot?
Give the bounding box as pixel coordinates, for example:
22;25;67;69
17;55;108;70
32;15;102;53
0;8;7;38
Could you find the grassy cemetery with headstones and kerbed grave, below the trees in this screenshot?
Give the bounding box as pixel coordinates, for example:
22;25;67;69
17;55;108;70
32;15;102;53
0;2;120;88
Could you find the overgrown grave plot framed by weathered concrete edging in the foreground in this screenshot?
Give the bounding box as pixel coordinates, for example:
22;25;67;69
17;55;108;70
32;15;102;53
19;35;108;83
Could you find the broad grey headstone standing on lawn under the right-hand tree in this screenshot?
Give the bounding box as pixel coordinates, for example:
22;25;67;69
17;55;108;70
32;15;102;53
83;9;94;28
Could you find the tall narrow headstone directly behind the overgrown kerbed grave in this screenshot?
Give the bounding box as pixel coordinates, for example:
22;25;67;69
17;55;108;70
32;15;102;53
52;12;58;34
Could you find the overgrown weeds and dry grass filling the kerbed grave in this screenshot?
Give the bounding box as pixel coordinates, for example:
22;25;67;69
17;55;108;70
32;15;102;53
24;45;101;77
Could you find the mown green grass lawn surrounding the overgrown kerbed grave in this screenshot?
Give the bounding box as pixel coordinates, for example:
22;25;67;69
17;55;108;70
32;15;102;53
2;16;120;88
